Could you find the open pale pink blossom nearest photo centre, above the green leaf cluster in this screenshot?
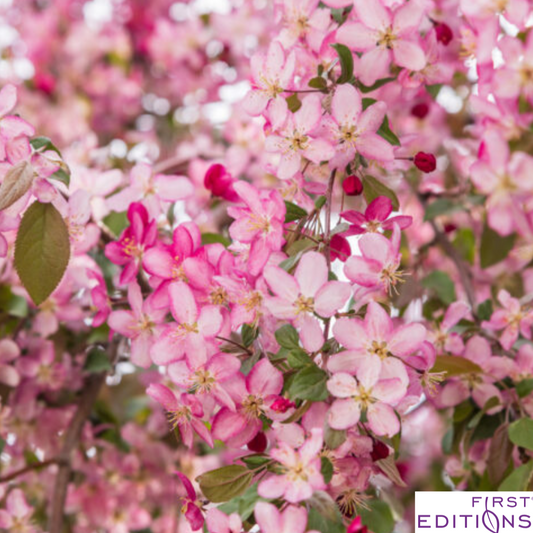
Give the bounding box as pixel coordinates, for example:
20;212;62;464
264;252;351;352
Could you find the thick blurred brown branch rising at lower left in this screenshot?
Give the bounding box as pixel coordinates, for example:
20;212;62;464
48;342;118;533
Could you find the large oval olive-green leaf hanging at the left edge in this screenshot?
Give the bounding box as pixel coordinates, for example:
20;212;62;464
15;202;70;305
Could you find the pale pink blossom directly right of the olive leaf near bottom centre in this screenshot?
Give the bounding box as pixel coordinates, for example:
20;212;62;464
257;429;325;503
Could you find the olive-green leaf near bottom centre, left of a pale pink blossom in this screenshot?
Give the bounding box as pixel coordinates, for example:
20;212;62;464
196;465;253;503
